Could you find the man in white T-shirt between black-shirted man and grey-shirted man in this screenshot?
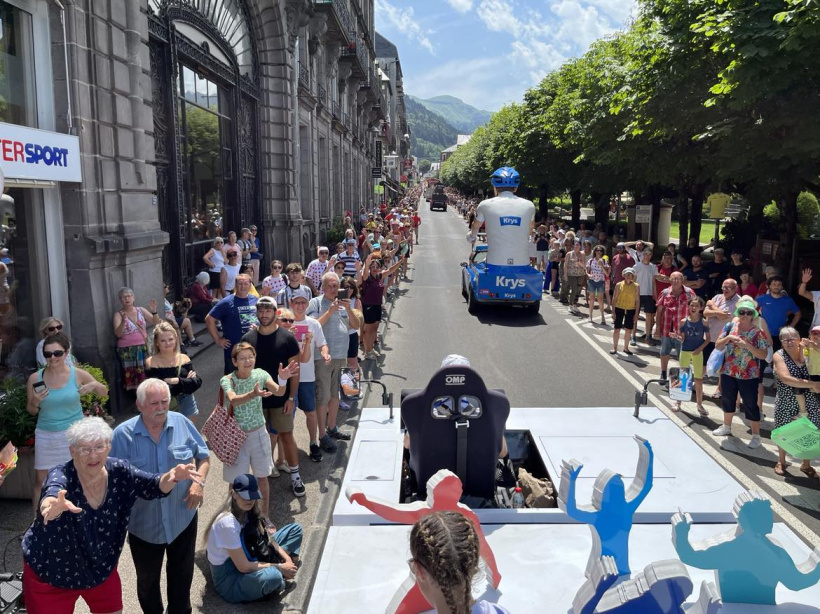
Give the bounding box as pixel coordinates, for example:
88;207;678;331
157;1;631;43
290;283;332;463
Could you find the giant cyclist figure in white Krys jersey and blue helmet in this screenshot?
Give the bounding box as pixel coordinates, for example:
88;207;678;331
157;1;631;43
467;166;535;266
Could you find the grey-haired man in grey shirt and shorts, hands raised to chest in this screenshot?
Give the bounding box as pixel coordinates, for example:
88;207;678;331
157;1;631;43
307;273;361;452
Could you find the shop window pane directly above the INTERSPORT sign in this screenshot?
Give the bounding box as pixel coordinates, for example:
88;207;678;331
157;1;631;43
0;0;37;128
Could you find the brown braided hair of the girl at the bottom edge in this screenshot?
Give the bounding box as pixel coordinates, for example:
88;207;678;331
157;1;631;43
410;512;479;614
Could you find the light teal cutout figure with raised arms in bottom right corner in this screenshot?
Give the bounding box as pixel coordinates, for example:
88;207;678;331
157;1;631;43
672;491;820;605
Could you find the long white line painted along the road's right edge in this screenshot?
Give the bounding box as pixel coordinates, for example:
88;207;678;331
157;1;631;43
566;319;820;547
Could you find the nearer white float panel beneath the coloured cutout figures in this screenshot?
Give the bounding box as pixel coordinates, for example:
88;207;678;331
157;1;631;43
308;523;820;614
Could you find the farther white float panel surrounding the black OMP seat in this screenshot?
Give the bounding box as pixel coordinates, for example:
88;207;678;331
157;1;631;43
333;407;743;526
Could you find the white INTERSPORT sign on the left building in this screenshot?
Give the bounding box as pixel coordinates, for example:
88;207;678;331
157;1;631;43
0;122;83;183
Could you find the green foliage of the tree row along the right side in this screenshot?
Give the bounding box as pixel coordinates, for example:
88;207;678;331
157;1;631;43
441;0;820;276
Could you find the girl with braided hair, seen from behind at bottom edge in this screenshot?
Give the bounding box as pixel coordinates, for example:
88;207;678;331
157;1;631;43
408;512;509;614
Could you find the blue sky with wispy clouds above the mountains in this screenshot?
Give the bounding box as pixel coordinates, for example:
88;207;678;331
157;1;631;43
375;0;636;111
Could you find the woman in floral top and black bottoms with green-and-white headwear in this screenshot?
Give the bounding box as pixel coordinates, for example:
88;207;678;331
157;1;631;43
712;299;769;450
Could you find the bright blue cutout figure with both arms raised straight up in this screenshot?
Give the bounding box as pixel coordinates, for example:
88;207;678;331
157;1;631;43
558;435;654;578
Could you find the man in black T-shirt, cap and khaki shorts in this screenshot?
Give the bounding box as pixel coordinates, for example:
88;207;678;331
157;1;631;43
242;300;308;497
